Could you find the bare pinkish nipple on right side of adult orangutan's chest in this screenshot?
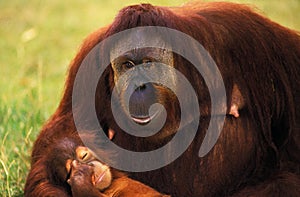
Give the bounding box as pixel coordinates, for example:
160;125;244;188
229;84;245;118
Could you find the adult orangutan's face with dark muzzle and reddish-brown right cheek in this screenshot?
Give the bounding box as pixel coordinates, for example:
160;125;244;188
111;48;183;150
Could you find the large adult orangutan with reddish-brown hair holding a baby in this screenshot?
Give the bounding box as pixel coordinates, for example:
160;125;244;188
25;3;300;196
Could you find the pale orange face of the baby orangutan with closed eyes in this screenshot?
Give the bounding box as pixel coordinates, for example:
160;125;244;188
66;146;112;191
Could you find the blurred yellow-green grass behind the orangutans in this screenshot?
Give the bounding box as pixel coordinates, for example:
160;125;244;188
0;0;300;196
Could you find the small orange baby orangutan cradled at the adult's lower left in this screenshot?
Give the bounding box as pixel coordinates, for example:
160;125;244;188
66;140;167;197
